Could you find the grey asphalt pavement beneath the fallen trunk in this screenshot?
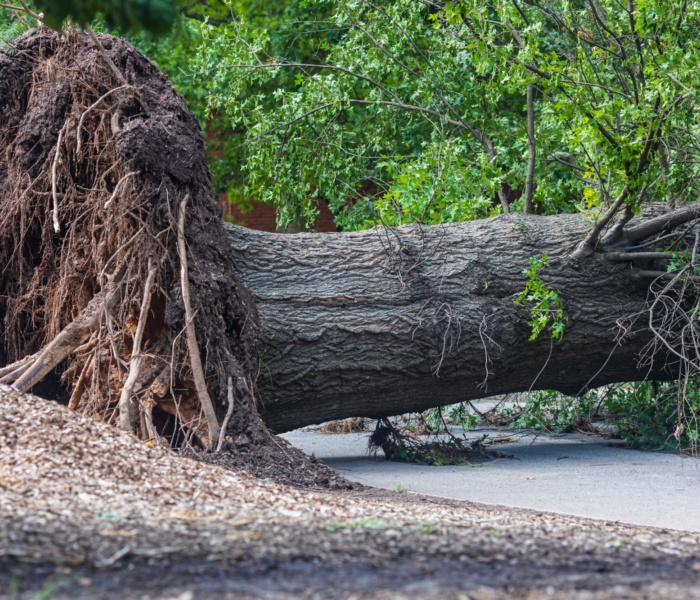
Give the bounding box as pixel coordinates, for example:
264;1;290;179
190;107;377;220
283;428;700;532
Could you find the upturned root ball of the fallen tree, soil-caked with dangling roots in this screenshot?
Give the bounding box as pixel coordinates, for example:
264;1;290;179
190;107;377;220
0;29;331;488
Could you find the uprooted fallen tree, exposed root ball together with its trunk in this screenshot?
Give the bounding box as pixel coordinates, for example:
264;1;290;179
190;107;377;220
0;30;700;464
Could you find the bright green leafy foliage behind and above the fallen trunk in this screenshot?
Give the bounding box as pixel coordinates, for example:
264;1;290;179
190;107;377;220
182;0;699;228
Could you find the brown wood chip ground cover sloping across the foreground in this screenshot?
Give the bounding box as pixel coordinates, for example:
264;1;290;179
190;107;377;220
0;387;700;600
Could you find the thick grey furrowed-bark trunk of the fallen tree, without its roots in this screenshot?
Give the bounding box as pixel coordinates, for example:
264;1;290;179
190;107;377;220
228;215;684;432
